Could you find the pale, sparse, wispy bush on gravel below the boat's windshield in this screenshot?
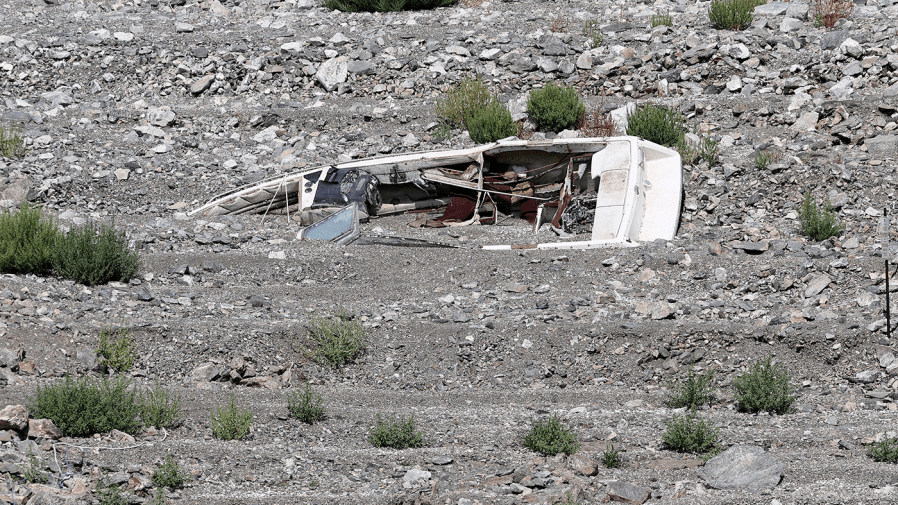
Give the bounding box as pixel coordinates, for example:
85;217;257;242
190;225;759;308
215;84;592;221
305;316;365;368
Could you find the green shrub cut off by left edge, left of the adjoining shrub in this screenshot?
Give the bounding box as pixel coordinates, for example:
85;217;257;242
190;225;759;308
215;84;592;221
0;203;59;275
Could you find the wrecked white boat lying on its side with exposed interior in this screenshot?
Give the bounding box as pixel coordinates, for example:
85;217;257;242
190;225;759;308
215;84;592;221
190;137;683;249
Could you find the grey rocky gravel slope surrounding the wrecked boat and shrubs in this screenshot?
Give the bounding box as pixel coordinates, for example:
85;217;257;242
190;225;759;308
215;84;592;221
0;0;898;504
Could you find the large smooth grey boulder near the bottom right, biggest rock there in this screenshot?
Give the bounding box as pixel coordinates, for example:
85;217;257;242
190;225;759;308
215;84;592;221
697;444;783;493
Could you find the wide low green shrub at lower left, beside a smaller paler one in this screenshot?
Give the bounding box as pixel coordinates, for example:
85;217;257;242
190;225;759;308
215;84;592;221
28;376;142;437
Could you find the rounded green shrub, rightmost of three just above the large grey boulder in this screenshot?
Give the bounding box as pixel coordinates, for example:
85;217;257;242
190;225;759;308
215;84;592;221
733;356;798;414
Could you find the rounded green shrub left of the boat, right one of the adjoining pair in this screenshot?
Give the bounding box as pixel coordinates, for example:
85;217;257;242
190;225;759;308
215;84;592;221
53;222;140;286
